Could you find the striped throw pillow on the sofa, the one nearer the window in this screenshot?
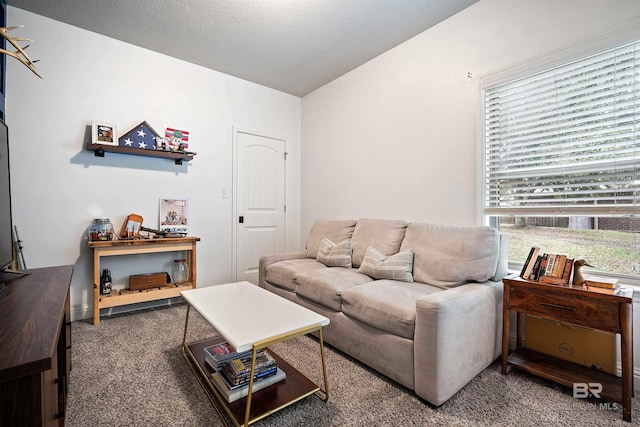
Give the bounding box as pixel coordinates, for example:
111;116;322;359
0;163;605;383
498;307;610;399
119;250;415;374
358;246;413;282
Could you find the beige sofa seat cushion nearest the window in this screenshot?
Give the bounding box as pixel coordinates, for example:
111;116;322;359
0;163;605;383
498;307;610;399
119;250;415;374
342;280;442;339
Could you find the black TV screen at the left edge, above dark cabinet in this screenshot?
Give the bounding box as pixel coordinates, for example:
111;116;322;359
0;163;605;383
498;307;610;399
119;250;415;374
0;121;13;271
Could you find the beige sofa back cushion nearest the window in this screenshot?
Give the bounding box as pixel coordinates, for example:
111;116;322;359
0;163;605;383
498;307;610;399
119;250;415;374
400;223;500;288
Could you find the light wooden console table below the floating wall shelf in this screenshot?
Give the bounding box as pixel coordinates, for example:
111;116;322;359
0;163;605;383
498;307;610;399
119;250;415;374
89;237;200;325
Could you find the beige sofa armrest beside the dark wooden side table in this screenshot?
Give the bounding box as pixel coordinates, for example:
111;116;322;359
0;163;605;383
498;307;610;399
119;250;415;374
414;282;502;406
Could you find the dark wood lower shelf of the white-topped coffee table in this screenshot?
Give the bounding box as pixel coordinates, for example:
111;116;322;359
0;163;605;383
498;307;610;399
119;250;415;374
183;337;320;426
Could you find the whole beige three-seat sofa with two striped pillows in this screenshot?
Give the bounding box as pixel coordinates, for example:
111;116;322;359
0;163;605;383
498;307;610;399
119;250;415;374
259;219;507;406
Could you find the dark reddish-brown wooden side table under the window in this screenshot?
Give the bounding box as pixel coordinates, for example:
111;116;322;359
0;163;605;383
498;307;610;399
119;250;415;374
502;277;633;421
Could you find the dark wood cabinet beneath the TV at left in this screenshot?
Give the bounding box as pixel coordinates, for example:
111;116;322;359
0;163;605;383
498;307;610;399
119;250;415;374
0;266;73;427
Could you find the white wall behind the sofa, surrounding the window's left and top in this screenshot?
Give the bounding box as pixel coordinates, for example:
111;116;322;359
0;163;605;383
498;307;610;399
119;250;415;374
301;0;640;239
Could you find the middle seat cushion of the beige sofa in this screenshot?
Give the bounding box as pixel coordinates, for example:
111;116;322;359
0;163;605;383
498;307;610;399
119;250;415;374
294;267;372;311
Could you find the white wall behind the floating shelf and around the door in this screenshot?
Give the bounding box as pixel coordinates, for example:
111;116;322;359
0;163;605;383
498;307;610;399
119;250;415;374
6;7;301;318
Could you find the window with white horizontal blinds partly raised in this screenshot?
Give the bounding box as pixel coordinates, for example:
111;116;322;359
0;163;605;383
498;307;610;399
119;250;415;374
483;38;640;275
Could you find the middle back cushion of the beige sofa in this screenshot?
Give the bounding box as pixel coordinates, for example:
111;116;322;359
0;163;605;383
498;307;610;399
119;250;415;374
351;218;407;268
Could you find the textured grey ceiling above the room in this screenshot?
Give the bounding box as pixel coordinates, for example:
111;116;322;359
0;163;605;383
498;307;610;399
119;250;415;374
8;0;478;96
